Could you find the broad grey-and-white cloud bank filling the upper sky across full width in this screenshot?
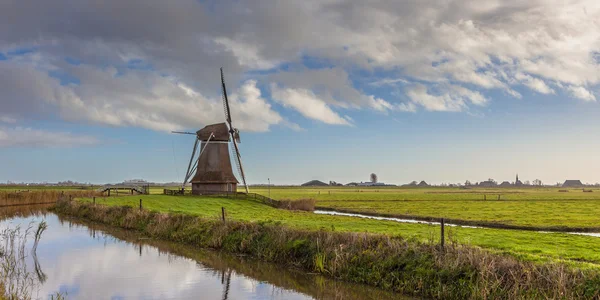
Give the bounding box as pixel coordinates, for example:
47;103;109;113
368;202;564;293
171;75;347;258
0;0;600;131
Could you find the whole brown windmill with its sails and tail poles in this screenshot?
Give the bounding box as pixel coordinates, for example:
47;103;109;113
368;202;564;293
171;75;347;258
173;68;249;194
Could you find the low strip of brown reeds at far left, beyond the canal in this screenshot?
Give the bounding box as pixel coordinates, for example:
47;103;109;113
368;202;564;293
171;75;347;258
0;190;102;207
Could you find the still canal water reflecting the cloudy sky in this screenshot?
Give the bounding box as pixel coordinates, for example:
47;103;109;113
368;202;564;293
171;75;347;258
0;208;403;299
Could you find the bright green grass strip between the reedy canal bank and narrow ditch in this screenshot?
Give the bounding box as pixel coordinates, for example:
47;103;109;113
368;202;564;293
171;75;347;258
82;195;600;267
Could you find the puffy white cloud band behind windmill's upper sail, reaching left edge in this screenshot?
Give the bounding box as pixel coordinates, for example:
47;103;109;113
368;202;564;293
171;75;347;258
0;59;282;132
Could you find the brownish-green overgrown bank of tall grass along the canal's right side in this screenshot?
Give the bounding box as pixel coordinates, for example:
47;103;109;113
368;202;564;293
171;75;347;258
55;202;600;299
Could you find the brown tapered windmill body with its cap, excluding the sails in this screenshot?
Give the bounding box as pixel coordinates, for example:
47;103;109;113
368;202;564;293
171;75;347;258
191;123;238;194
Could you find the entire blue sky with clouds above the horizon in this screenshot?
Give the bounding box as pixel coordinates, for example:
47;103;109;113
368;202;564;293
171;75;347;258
0;0;600;184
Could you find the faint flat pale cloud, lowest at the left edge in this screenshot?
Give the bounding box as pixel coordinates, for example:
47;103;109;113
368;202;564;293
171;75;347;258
0;127;99;148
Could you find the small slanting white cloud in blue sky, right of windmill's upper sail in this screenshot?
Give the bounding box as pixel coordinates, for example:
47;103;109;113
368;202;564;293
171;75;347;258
271;84;350;125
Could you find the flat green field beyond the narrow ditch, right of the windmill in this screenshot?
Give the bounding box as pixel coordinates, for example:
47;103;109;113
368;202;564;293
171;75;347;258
252;187;600;232
